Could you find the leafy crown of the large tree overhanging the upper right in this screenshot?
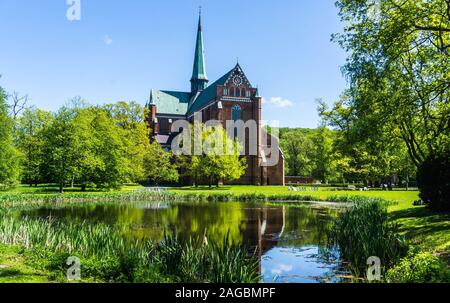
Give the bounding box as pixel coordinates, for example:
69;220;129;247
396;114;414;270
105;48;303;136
321;0;450;175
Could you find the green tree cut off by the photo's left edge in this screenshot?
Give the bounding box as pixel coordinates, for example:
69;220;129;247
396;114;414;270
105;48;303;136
0;87;20;189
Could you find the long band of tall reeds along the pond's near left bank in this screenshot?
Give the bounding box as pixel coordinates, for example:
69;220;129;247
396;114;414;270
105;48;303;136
0;215;259;283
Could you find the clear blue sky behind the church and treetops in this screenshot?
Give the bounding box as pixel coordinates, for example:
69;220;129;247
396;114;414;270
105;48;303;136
0;0;345;128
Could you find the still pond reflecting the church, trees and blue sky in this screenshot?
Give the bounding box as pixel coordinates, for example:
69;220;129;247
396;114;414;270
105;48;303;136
21;202;346;283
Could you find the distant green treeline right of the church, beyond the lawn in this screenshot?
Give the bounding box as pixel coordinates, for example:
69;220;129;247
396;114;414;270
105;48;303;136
270;127;416;186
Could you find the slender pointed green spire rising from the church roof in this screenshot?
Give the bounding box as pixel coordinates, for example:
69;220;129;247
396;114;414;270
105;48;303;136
191;7;208;94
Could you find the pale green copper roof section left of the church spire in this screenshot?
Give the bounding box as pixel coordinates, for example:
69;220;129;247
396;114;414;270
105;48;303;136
150;90;191;115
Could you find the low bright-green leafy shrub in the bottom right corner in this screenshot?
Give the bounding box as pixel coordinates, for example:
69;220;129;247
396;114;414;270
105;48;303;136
385;253;450;283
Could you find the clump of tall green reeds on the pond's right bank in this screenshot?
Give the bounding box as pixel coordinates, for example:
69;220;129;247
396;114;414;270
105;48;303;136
329;198;408;276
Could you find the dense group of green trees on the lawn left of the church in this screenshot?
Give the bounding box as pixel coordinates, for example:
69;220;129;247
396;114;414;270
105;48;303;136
11;98;174;192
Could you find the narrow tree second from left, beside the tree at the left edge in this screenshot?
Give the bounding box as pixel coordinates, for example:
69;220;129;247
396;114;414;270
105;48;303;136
16;108;53;186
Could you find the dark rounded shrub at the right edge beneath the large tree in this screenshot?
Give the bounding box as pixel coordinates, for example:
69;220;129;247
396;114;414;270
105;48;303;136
417;149;450;211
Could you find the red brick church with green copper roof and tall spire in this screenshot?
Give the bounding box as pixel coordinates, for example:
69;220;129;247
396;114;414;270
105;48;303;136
148;16;284;185
